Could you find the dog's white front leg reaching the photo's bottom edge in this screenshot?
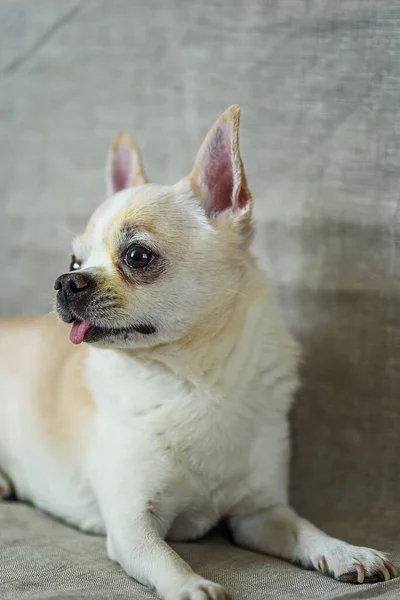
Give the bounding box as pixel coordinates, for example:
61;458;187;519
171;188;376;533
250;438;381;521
97;472;230;600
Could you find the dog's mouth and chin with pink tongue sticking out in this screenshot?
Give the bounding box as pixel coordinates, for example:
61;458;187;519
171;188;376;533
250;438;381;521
57;306;157;347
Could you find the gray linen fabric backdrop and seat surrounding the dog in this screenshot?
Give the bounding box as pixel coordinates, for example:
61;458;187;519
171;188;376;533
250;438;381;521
0;0;400;600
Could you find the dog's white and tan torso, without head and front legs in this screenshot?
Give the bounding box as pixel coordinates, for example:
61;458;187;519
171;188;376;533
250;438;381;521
0;280;297;539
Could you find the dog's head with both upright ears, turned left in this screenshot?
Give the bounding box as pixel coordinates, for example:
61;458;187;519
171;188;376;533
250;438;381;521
54;106;252;348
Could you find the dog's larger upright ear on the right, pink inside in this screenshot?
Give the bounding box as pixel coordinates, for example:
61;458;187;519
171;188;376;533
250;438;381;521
189;105;251;223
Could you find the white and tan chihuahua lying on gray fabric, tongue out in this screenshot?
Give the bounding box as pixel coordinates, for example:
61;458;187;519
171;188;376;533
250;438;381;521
0;106;396;600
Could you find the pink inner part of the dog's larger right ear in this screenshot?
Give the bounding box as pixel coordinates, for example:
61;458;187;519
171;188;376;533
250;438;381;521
202;124;235;214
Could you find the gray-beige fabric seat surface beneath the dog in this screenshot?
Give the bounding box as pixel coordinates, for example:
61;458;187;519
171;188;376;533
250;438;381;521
0;503;400;600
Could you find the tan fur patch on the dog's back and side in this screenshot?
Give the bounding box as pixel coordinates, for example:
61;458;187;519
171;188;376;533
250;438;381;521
0;316;94;452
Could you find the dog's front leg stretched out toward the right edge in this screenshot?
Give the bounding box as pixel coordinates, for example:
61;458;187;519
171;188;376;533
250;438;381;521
230;505;397;583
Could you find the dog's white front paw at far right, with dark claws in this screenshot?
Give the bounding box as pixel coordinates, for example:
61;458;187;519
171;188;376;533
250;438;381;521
317;542;397;583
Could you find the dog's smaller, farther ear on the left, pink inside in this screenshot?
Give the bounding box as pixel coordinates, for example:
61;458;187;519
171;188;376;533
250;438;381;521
106;133;147;196
